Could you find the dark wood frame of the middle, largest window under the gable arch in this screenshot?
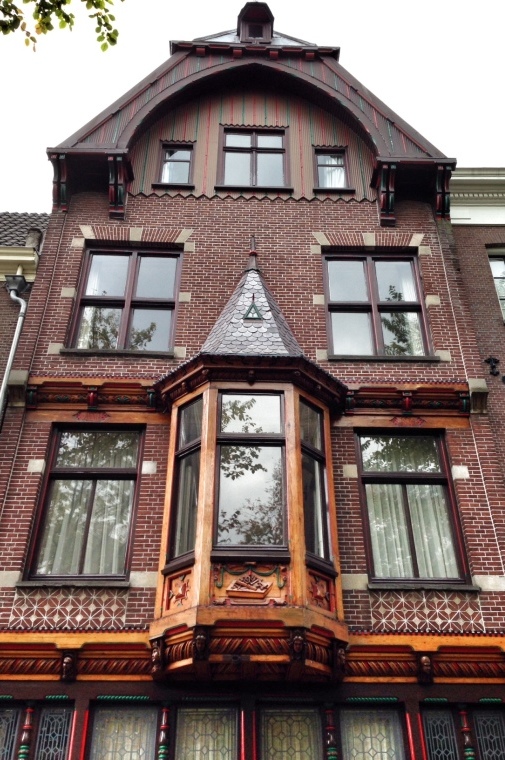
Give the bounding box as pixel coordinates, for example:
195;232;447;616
215;125;293;193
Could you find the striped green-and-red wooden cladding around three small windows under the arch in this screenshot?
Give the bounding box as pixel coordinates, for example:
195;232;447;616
130;88;375;200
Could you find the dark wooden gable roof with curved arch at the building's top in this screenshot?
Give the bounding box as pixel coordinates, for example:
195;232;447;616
52;32;445;160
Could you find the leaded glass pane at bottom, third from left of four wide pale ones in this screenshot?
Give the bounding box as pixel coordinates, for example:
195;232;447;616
260;708;322;760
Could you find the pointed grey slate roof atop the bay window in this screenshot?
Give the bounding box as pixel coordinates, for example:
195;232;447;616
201;253;303;356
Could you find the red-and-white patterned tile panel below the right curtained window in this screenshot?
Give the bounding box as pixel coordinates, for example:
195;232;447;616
370;590;485;633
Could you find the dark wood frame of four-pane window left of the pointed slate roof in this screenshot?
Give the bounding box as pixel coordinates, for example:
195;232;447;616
68;246;182;356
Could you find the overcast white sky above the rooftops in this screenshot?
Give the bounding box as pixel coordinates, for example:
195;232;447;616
0;0;505;211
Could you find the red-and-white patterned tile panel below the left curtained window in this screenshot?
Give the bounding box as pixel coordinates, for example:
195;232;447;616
9;588;128;631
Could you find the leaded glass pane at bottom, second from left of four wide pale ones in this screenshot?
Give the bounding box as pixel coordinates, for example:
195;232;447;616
175;707;237;760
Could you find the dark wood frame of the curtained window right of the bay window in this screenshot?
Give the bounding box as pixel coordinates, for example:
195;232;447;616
355;428;470;591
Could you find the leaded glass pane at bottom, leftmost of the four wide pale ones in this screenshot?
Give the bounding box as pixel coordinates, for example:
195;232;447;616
90;707;158;760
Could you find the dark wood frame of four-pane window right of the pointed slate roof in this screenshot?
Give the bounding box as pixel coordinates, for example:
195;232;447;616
323;251;439;362
